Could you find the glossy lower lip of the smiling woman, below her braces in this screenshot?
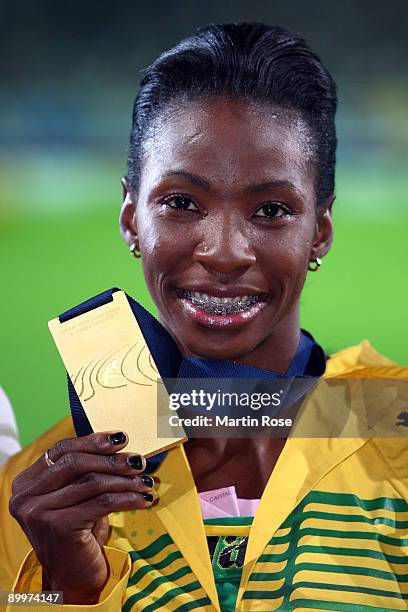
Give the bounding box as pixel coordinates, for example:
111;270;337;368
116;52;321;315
179;295;267;329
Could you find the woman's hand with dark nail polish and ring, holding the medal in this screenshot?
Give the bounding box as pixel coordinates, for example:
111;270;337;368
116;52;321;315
10;432;153;604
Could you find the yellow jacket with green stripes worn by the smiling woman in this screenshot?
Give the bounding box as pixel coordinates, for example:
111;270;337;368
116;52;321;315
0;341;408;612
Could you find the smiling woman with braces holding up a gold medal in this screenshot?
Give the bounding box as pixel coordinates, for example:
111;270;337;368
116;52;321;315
2;24;408;612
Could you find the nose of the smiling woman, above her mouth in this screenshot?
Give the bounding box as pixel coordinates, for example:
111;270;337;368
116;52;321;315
194;222;256;274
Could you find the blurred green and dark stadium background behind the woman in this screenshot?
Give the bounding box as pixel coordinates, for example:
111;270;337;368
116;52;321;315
0;0;408;444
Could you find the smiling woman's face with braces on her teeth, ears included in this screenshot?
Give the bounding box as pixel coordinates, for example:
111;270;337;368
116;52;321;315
121;98;332;367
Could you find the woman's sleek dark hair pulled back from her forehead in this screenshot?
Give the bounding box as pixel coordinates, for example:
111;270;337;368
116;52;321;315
128;23;337;205
